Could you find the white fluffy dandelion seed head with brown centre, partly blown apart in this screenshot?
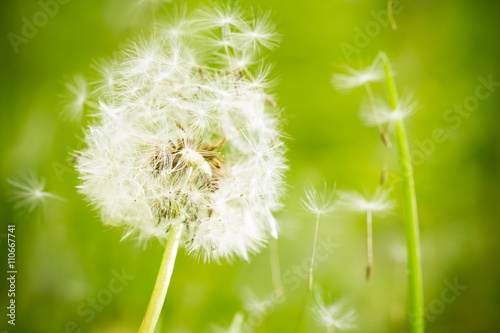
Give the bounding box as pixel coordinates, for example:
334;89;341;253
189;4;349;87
73;3;287;261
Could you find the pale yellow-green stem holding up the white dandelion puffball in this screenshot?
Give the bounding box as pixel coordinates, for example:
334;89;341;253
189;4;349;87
139;224;182;333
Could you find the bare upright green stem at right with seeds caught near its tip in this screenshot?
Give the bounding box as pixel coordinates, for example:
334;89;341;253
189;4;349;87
380;52;424;333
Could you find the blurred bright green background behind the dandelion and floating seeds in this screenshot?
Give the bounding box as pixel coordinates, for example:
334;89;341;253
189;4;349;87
0;0;500;333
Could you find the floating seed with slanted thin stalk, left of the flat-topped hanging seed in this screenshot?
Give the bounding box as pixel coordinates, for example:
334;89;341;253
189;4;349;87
302;183;336;290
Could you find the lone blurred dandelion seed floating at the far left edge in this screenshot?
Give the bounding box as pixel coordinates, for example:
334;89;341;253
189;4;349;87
7;173;64;214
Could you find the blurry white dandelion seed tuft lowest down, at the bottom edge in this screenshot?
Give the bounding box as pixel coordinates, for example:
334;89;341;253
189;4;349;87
311;289;357;333
